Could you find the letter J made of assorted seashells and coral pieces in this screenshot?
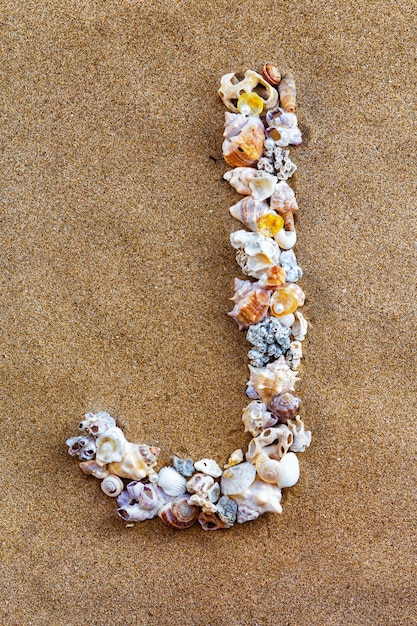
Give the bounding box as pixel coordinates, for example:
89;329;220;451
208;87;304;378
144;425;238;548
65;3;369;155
66;63;311;530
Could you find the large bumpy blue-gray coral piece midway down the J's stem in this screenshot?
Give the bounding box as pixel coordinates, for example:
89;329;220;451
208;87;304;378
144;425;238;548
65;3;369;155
246;317;291;367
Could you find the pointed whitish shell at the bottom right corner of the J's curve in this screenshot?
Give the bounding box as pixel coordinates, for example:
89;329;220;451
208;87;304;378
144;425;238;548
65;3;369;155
232;478;282;524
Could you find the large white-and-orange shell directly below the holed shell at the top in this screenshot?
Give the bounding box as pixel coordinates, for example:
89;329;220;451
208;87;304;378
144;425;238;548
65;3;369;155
222;113;265;167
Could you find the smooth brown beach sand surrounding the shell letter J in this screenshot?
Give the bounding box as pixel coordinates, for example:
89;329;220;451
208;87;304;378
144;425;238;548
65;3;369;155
0;0;417;626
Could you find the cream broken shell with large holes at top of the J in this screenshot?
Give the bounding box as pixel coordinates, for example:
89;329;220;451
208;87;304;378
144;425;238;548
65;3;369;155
218;70;278;113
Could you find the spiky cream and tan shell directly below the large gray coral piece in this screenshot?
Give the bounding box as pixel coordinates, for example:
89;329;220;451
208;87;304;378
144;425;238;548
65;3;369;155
247;356;299;405
